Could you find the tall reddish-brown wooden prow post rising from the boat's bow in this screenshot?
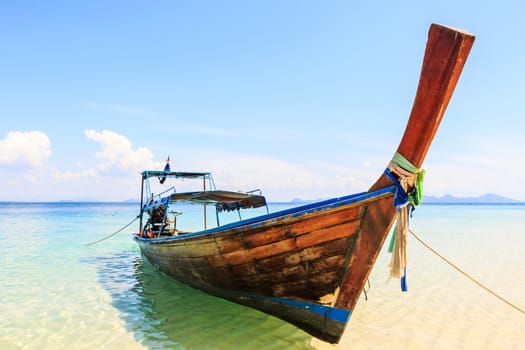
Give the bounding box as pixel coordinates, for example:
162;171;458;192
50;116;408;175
335;24;474;310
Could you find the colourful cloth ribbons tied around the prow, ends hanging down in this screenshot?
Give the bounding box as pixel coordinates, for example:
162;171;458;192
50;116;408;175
385;152;425;292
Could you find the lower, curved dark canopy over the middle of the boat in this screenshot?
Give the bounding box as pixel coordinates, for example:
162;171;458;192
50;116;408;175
170;191;266;211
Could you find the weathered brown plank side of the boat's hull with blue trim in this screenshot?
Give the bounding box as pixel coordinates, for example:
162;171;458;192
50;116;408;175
136;187;394;343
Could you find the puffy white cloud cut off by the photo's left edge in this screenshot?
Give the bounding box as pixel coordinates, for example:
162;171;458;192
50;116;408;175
0;131;51;168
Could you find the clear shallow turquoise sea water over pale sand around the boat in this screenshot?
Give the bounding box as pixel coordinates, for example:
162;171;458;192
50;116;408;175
0;203;525;350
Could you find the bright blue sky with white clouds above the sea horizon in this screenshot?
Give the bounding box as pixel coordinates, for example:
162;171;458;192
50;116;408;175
0;0;525;201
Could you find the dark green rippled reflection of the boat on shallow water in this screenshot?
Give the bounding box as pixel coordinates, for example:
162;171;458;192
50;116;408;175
92;252;312;349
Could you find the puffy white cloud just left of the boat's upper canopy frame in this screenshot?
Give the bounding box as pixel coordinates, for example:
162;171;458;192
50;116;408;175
84;130;158;172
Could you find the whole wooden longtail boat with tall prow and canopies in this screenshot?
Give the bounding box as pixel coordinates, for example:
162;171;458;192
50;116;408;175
134;24;474;343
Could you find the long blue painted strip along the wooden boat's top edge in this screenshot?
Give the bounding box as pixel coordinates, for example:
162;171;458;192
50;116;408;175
134;186;396;244
